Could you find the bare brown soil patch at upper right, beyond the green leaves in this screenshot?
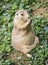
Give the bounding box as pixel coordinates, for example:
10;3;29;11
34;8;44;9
33;6;48;18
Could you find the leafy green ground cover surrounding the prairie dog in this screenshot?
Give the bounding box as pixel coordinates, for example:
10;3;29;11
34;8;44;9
0;0;48;65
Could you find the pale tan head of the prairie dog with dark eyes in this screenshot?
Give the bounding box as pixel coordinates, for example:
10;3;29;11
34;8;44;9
14;10;29;21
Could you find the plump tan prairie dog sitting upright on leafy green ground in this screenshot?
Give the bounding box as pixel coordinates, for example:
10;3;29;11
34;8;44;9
11;10;39;58
